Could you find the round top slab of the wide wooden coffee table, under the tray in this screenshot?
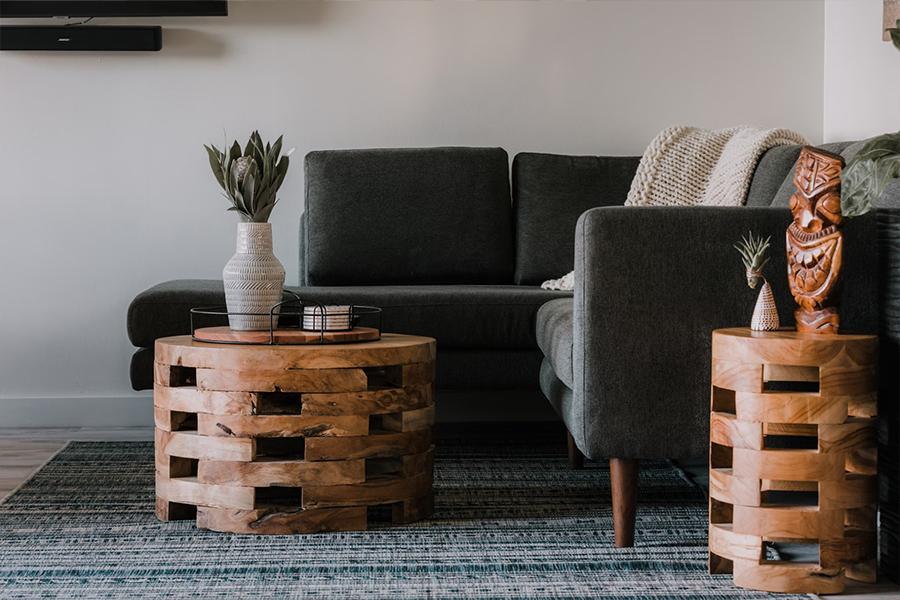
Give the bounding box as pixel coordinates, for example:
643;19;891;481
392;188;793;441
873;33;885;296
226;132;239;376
155;333;437;372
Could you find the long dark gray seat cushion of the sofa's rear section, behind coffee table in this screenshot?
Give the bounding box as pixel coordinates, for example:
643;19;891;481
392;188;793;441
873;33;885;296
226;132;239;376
128;280;572;349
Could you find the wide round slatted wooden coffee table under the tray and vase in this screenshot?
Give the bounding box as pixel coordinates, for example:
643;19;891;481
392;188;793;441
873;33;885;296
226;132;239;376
153;334;435;534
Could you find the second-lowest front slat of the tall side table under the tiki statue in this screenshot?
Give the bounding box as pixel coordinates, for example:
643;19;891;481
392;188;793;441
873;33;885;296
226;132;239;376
734;505;844;540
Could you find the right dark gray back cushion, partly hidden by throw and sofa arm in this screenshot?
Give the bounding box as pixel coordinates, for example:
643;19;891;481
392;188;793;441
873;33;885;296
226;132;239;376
513;152;641;285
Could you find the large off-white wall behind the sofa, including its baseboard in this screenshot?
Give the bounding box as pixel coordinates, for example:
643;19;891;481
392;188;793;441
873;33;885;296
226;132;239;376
0;0;824;426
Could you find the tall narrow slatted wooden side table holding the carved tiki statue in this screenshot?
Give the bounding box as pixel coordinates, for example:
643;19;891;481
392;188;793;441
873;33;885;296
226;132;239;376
709;328;878;594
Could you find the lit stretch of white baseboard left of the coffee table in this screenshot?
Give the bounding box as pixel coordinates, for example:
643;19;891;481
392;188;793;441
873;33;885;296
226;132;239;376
0;394;153;428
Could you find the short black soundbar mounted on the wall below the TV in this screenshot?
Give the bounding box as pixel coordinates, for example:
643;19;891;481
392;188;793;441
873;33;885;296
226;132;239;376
0;25;162;52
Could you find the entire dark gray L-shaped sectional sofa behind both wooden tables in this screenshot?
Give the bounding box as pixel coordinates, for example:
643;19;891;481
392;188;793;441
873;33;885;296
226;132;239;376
128;143;900;572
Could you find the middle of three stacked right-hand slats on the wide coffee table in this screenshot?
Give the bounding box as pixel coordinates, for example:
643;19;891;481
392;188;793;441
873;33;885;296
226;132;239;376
304;429;434;460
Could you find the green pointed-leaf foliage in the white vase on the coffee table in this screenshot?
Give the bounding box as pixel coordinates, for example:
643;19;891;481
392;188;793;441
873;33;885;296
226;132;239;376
203;131;294;223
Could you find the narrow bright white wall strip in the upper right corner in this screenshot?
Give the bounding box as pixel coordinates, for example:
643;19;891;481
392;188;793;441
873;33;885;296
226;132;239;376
823;0;900;142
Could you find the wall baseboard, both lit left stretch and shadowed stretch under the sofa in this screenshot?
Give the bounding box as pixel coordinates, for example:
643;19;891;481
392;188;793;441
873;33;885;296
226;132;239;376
0;391;558;428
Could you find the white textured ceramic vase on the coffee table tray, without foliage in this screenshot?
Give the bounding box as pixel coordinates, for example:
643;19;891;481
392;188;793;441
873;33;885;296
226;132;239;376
222;223;284;331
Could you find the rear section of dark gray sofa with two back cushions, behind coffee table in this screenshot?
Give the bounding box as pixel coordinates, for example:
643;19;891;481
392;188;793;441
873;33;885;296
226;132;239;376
128;148;639;394
